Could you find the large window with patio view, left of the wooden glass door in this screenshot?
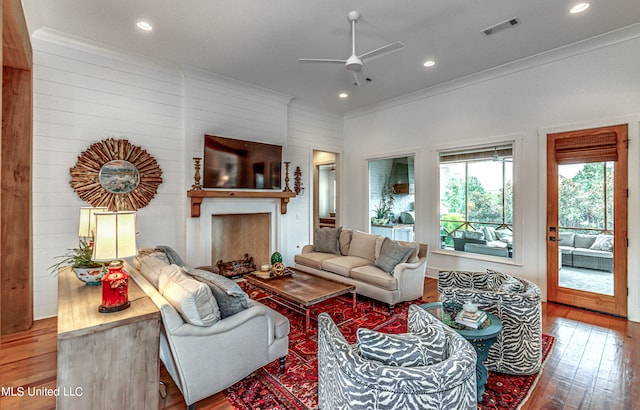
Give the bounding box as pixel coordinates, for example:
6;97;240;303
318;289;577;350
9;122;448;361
440;143;513;258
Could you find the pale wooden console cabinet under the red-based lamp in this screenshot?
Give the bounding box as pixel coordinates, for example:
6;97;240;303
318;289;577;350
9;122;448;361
56;268;160;410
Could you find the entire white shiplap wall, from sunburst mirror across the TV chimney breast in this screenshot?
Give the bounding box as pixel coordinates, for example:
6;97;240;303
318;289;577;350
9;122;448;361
32;30;343;319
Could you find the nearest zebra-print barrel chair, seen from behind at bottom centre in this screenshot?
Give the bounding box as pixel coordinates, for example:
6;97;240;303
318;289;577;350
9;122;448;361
318;305;477;410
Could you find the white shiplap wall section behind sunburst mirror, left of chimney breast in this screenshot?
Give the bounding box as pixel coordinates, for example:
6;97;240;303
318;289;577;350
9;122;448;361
32;30;186;318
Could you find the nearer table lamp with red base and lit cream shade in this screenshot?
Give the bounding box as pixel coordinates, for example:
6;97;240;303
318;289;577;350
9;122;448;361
91;212;137;313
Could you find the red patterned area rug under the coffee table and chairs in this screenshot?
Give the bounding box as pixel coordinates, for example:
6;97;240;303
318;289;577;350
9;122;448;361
224;291;553;410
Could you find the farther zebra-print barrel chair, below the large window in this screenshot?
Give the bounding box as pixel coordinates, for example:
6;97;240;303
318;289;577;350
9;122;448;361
438;270;542;375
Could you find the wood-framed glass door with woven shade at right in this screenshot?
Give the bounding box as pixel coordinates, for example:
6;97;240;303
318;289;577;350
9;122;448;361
546;125;628;317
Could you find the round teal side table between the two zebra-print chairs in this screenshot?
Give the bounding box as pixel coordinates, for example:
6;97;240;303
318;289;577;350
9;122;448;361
420;302;502;403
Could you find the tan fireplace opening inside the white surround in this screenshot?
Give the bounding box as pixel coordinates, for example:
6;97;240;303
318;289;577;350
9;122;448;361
211;213;271;266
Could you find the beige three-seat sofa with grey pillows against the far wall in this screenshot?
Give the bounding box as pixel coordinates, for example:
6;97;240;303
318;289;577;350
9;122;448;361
294;228;428;312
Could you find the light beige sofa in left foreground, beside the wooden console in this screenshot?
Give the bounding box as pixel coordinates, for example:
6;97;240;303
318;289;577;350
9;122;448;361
126;248;290;409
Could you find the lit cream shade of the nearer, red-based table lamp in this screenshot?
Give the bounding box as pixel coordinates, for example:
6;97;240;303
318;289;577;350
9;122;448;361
91;212;137;262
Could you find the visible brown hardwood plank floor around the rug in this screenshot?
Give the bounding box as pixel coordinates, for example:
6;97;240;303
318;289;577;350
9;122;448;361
0;279;640;410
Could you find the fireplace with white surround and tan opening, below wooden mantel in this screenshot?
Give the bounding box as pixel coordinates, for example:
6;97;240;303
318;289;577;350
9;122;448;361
186;197;280;266
